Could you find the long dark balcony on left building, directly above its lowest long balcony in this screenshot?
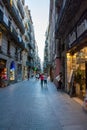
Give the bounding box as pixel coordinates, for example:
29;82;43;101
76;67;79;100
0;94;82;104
3;0;25;34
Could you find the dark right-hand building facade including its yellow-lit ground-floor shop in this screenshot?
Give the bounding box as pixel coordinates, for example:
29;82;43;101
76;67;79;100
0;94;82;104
45;0;87;98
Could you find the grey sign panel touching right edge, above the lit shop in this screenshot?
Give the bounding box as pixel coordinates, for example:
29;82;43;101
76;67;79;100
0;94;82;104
77;19;87;37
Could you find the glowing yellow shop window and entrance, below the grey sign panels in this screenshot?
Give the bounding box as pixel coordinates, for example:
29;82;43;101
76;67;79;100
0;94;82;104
67;47;87;99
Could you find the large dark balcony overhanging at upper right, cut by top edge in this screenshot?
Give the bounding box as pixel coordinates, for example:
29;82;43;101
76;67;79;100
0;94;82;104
56;0;82;37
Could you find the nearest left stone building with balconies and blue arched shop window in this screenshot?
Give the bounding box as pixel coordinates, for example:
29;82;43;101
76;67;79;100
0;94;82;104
0;0;25;86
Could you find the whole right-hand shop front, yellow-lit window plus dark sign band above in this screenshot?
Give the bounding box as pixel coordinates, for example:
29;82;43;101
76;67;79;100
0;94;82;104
66;11;87;99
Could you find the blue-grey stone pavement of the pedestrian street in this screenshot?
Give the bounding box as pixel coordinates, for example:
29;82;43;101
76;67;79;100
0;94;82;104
0;79;87;130
